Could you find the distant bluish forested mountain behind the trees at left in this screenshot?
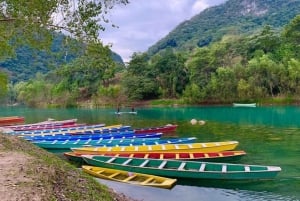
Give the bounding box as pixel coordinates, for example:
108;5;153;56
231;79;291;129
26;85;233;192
0;35;124;83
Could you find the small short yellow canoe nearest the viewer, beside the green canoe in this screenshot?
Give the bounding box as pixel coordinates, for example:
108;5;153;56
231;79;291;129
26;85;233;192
82;165;177;189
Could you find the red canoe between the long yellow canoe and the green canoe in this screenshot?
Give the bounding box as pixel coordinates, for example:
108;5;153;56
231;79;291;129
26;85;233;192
64;151;246;163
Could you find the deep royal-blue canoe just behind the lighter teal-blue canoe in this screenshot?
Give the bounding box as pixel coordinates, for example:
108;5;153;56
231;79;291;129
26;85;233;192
22;131;162;141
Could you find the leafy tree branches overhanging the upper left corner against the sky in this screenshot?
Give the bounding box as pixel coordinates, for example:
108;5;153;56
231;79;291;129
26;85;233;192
0;0;128;58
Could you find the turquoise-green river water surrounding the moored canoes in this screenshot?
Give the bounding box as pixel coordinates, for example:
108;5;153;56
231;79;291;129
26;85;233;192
0;106;300;201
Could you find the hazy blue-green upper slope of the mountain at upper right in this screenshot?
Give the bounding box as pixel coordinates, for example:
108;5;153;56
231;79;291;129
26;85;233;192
148;0;300;55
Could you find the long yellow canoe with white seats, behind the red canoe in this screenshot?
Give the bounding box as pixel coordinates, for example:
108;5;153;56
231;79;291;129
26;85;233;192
72;141;238;154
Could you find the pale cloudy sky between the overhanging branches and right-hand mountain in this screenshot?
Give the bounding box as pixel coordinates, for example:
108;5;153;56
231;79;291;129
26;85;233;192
100;0;226;62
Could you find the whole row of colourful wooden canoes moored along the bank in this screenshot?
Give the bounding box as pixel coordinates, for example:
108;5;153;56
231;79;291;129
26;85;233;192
0;117;281;188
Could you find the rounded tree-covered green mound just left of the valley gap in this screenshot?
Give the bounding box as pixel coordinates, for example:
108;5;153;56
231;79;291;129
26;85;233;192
55;42;115;99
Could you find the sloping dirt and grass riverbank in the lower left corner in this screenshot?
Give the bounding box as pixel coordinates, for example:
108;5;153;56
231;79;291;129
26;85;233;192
0;134;137;201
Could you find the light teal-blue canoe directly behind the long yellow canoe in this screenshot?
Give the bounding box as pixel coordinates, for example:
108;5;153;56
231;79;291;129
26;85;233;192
32;137;196;149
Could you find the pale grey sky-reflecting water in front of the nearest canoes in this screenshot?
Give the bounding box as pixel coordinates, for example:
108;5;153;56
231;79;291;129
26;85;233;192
97;179;298;201
